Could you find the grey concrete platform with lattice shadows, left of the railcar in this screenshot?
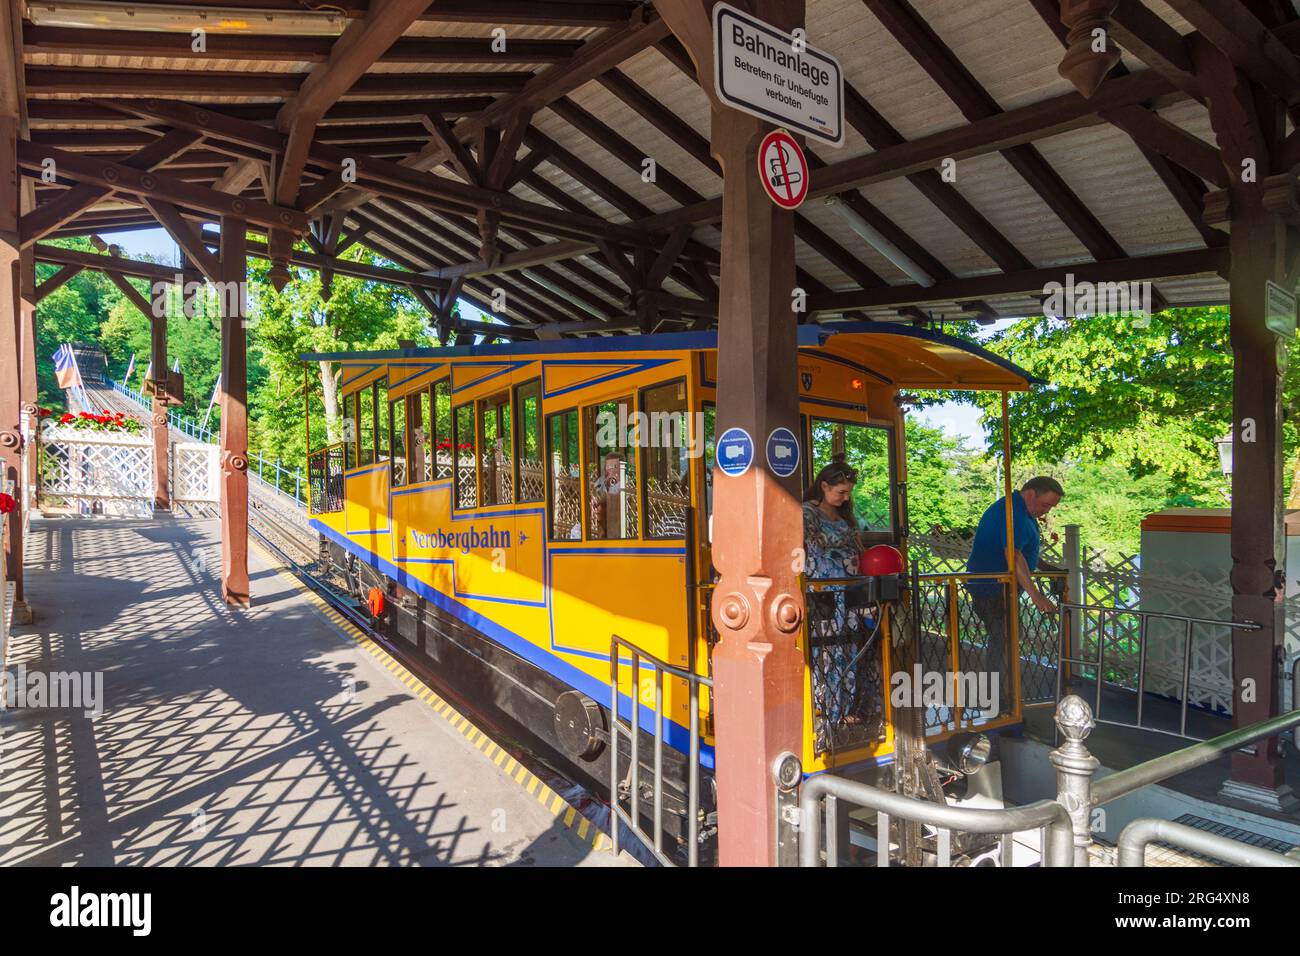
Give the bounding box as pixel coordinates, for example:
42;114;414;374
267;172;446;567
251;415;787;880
0;518;629;866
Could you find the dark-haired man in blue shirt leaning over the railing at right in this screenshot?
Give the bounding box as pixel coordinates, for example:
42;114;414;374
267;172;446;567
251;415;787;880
966;475;1065;713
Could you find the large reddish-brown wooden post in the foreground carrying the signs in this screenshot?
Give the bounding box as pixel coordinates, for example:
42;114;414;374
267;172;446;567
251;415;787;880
655;0;806;866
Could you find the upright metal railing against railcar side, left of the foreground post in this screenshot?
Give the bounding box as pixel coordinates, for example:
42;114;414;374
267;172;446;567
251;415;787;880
610;635;714;866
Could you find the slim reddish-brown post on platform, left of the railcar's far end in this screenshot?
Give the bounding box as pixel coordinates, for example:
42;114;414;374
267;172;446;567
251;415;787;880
217;216;250;607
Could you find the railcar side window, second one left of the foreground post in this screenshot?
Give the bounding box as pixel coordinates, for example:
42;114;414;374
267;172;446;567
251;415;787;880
582;398;640;538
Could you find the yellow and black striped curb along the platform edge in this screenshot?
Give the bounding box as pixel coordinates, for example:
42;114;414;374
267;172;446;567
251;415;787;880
250;537;614;851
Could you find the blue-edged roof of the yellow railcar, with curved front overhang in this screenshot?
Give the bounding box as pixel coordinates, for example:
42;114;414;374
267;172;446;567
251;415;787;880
298;323;1047;390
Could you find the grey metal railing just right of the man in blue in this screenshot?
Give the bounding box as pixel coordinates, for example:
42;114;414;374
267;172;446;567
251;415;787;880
1056;602;1261;740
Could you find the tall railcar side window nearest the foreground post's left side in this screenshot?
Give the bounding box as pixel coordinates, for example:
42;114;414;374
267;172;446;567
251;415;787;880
640;380;701;538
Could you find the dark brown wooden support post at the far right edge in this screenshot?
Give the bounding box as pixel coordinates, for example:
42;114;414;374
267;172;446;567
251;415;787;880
1191;38;1297;810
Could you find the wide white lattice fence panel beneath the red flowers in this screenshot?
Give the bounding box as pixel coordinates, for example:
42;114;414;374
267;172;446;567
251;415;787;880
39;428;153;515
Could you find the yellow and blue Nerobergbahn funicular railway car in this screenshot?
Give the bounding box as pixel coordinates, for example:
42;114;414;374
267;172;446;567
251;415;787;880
300;323;1039;858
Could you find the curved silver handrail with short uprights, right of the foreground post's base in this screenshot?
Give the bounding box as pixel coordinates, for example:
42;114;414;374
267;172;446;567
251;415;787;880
800;774;1074;868
